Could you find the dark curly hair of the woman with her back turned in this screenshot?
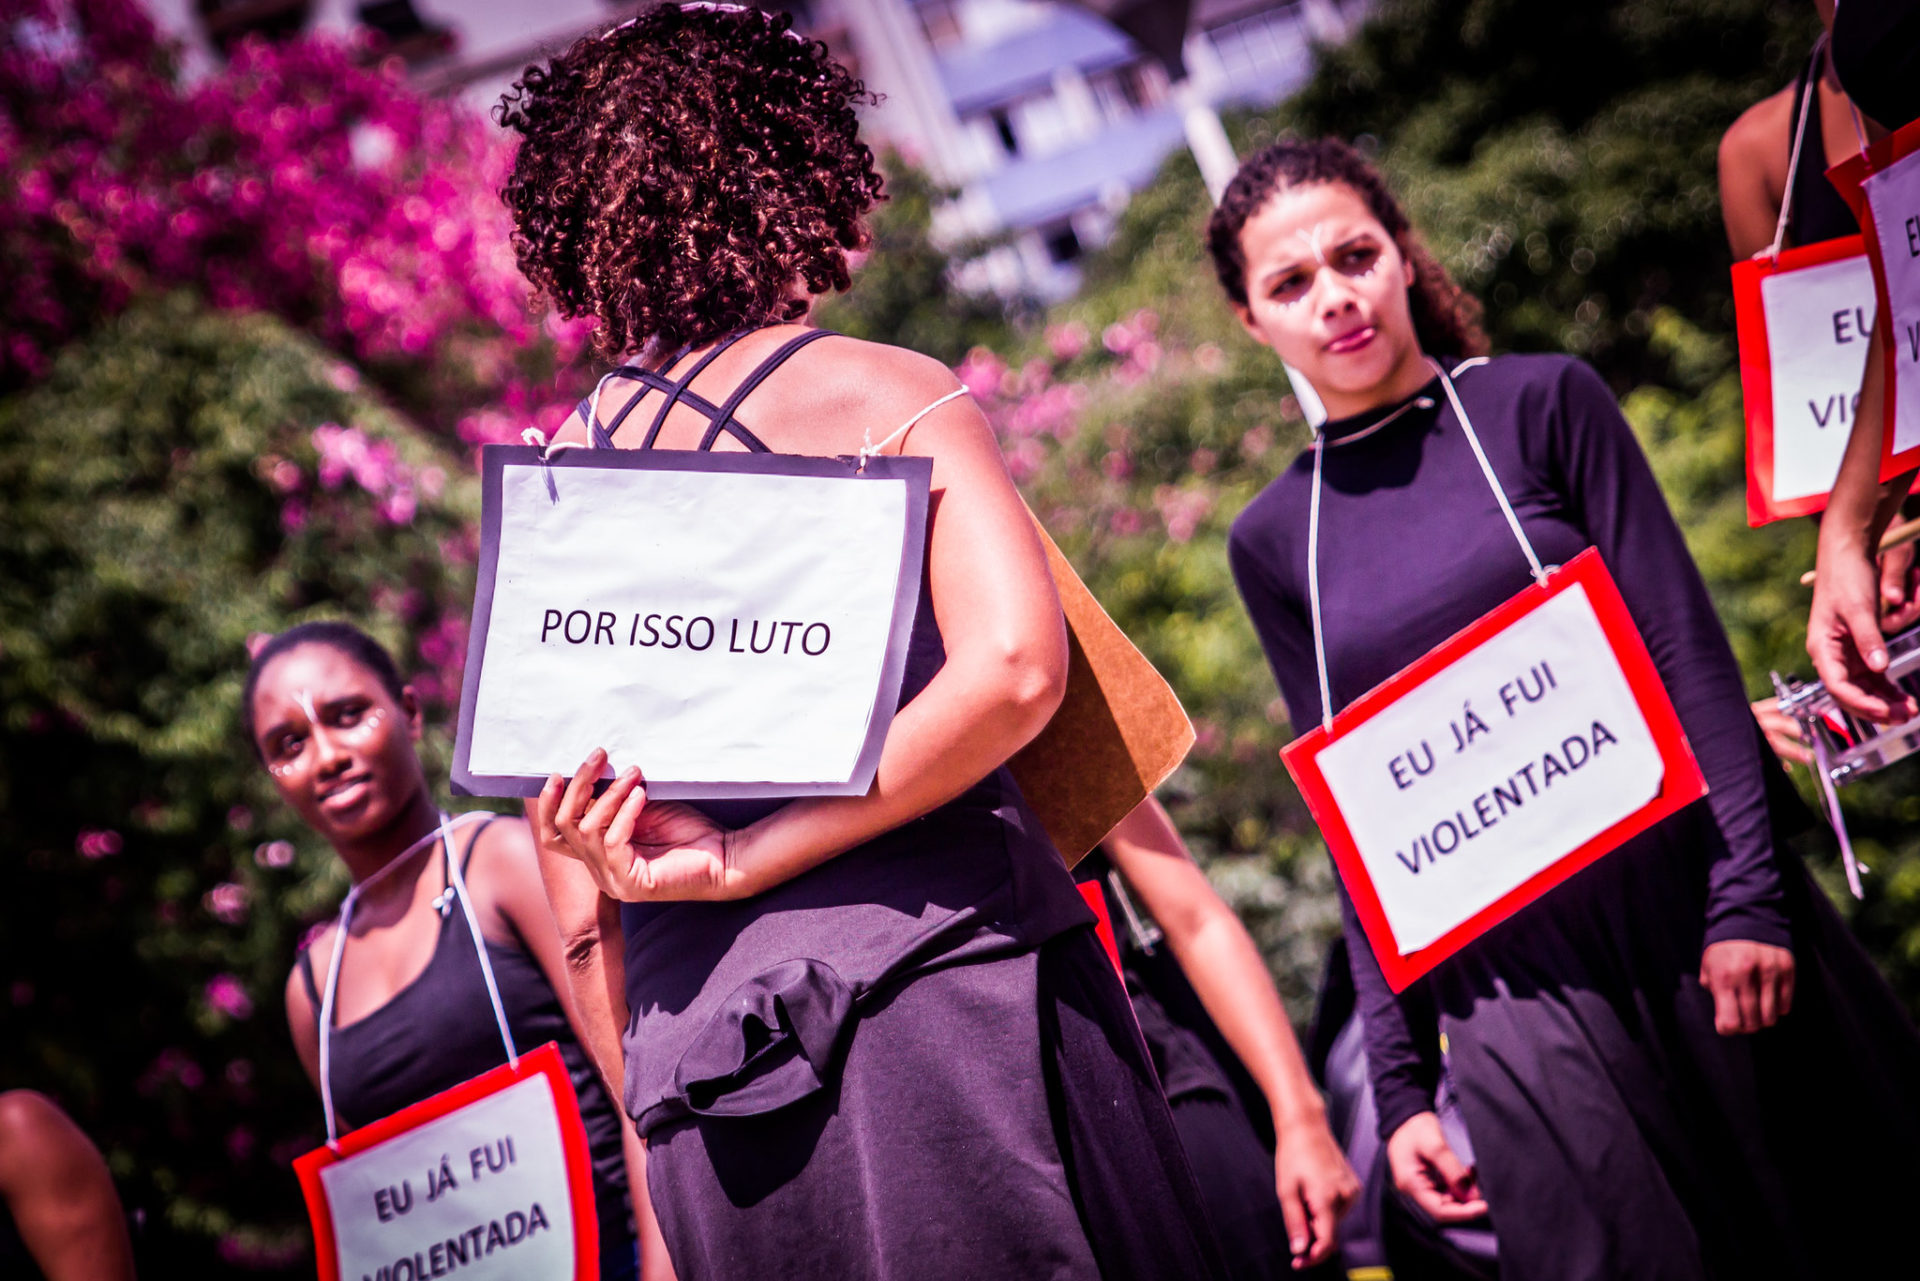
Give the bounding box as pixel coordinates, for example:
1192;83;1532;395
493;4;883;355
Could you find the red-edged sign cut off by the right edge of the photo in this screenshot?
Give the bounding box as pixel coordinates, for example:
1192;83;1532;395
1828;121;1920;480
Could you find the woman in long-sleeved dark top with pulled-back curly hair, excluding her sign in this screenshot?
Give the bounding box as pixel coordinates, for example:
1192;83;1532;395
1208;140;1920;1281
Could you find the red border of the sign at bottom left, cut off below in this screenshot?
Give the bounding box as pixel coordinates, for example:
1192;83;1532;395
294;1041;599;1281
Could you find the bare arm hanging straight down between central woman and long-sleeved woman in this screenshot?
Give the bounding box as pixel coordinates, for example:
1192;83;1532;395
1102;797;1359;1266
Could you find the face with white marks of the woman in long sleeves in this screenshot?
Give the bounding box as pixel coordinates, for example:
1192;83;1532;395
1235;182;1428;417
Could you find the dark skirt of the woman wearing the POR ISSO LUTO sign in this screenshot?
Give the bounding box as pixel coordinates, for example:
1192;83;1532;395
647;928;1221;1281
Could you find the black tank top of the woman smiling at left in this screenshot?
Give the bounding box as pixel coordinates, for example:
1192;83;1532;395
300;818;634;1275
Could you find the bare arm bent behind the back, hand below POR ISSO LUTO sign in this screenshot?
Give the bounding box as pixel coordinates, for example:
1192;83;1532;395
536;353;1066;901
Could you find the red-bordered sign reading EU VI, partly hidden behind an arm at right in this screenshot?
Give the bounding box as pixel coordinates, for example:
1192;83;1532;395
1734;236;1876;526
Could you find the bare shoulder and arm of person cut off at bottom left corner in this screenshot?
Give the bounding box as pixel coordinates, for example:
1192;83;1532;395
0;1089;132;1281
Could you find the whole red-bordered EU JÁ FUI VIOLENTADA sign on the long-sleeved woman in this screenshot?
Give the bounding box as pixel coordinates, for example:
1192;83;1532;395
1281;547;1707;991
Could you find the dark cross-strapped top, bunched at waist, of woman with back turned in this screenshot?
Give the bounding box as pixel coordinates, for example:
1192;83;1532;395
582;328;1092;1135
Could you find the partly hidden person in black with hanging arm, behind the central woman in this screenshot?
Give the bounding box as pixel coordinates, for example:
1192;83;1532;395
1073;797;1359;1279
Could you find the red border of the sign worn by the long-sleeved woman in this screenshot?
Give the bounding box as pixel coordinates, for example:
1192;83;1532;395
1281;547;1707;993
